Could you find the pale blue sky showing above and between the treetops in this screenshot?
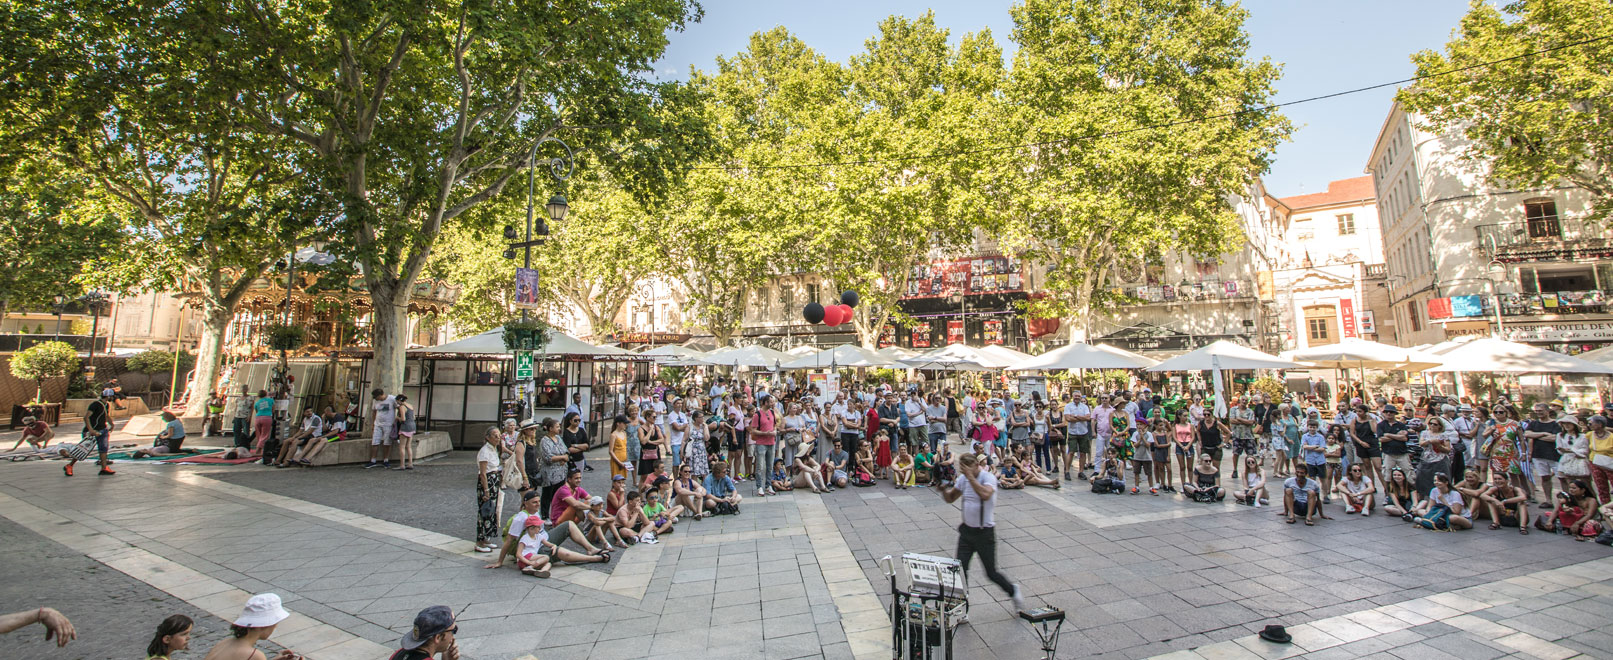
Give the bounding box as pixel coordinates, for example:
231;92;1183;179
658;0;1468;197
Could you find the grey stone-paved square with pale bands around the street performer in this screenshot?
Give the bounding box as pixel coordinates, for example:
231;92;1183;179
0;442;1613;660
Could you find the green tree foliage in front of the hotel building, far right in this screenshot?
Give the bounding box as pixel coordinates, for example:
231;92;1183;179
1397;0;1613;219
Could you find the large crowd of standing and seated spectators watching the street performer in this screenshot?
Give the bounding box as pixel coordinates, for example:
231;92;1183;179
477;372;1613;548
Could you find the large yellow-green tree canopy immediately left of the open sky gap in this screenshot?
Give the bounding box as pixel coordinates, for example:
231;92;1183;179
990;0;1290;334
